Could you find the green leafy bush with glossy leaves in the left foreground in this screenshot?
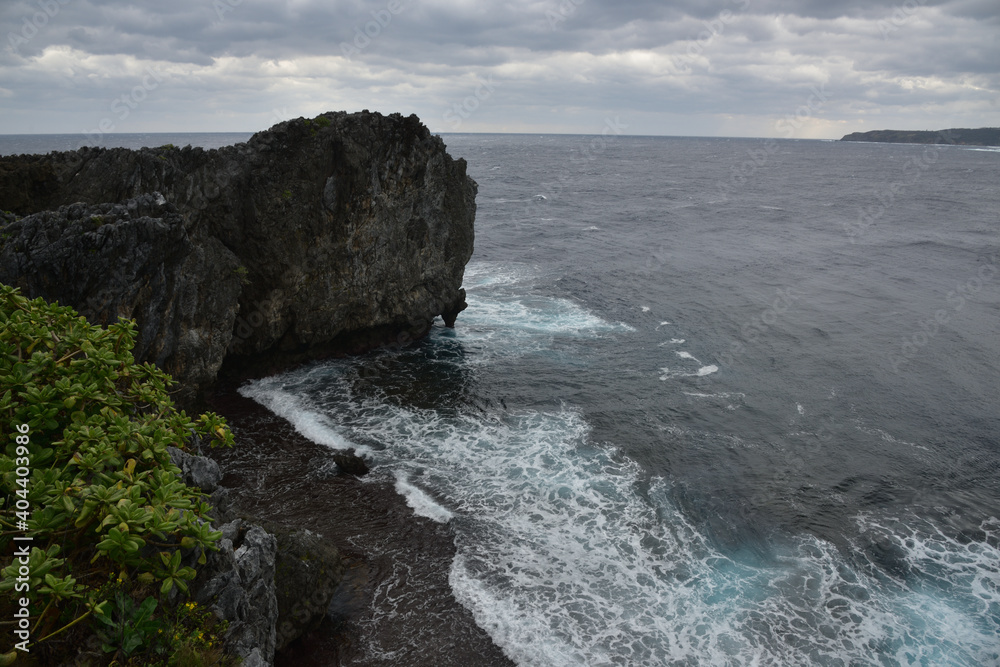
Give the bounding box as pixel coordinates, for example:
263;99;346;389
0;285;233;663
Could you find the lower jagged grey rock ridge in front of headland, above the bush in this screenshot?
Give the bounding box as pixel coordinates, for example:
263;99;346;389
0;193;241;400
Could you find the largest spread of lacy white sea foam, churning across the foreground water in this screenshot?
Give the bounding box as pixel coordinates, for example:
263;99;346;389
248;369;1000;667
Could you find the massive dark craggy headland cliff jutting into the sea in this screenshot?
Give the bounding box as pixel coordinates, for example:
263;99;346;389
0;112;477;399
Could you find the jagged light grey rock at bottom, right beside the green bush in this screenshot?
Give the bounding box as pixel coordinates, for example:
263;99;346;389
192;520;278;665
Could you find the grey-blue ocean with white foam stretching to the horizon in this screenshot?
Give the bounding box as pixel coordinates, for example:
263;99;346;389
0;134;1000;667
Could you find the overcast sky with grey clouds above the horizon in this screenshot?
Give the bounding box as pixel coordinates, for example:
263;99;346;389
0;0;1000;139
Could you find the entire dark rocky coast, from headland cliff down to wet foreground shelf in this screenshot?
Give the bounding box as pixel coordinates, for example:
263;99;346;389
0;111;494;666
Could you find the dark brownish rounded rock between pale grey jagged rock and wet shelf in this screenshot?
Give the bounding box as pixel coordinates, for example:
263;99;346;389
271;527;344;651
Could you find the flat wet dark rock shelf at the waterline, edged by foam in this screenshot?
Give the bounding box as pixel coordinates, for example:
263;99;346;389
208;385;513;667
